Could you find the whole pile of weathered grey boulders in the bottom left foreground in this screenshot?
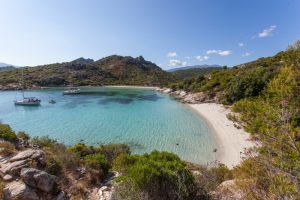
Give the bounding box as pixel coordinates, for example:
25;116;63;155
0;149;65;200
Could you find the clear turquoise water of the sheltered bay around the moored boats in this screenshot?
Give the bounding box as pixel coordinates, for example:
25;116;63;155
0;87;216;163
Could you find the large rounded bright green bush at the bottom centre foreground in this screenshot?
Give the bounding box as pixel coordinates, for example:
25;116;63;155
114;151;195;200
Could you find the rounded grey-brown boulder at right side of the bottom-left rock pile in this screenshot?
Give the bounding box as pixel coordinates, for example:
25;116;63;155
21;168;57;193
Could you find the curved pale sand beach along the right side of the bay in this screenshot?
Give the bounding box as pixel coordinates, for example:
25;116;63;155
189;103;255;168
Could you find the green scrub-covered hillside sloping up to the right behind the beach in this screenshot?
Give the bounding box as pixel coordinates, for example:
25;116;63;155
168;50;300;104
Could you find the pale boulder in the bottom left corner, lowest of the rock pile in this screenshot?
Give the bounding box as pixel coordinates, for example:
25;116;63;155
4;181;40;200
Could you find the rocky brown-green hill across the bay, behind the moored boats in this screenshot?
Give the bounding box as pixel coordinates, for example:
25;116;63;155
0;55;174;87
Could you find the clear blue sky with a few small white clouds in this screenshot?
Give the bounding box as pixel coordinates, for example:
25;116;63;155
0;0;300;69
